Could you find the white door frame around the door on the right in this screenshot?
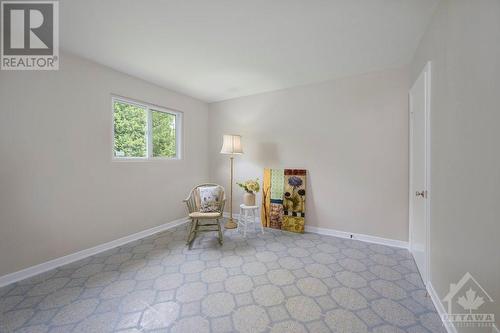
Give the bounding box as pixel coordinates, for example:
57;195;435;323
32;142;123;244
408;61;432;287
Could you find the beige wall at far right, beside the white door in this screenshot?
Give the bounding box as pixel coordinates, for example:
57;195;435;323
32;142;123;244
411;0;500;332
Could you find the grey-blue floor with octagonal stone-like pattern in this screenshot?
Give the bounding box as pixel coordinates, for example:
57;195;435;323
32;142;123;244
0;220;445;333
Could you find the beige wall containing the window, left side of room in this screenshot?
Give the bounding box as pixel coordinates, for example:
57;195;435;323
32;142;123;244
0;53;208;276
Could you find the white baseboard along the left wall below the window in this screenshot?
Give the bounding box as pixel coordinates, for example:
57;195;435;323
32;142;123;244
0;217;188;287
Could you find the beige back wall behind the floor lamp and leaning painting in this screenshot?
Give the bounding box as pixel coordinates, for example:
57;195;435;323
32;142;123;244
209;68;408;241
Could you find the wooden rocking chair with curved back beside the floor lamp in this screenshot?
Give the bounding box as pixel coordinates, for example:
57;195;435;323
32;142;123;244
184;183;226;249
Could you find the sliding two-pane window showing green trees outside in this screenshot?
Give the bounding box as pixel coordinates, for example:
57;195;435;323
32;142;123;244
112;97;182;159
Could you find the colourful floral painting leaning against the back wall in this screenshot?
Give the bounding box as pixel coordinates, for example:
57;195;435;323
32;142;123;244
261;169;306;233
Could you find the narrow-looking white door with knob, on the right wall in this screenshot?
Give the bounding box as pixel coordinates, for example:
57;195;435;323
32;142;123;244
409;63;431;285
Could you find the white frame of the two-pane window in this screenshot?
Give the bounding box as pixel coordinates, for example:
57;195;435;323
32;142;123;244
111;95;183;161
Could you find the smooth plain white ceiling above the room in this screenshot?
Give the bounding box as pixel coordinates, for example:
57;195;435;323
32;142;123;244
59;0;438;102
